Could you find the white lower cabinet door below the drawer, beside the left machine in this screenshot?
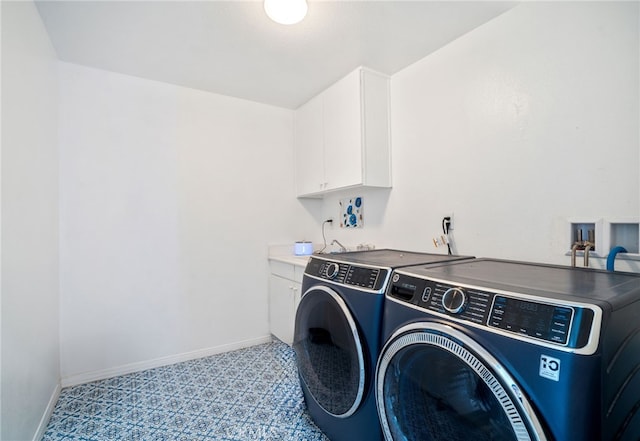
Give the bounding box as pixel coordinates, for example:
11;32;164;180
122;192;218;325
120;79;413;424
269;274;301;345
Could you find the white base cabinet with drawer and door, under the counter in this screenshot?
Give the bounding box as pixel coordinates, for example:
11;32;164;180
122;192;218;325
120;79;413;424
269;261;304;345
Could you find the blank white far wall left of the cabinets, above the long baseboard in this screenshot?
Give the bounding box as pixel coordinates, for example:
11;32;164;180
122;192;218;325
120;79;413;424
60;63;312;384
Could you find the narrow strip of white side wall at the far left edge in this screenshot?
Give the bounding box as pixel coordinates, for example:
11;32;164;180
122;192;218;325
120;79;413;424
0;2;59;441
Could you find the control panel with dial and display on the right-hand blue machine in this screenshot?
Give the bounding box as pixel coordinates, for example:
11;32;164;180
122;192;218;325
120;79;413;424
387;272;594;348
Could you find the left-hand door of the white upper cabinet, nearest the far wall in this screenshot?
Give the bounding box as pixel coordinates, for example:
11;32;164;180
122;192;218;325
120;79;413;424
294;96;325;196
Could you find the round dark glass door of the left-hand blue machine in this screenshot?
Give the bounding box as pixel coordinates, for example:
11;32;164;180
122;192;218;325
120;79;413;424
293;286;366;418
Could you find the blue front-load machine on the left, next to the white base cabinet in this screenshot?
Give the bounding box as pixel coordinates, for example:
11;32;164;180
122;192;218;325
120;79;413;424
293;249;468;441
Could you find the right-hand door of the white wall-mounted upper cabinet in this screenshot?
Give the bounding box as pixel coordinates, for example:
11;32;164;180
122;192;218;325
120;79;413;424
323;69;362;190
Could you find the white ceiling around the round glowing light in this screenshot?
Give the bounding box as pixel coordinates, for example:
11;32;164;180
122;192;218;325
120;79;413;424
36;0;516;108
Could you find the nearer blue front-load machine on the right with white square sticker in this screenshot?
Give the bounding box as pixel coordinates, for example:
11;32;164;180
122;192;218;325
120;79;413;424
375;259;640;441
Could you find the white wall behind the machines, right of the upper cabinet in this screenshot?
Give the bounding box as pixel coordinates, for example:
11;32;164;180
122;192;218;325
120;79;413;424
323;2;640;271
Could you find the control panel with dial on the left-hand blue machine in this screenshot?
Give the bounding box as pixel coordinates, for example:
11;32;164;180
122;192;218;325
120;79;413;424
305;257;389;291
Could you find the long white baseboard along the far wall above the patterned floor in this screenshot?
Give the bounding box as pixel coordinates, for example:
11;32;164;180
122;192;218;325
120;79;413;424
61;335;273;388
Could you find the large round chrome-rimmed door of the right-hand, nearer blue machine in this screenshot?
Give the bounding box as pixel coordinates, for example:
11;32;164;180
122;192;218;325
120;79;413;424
376;322;546;441
